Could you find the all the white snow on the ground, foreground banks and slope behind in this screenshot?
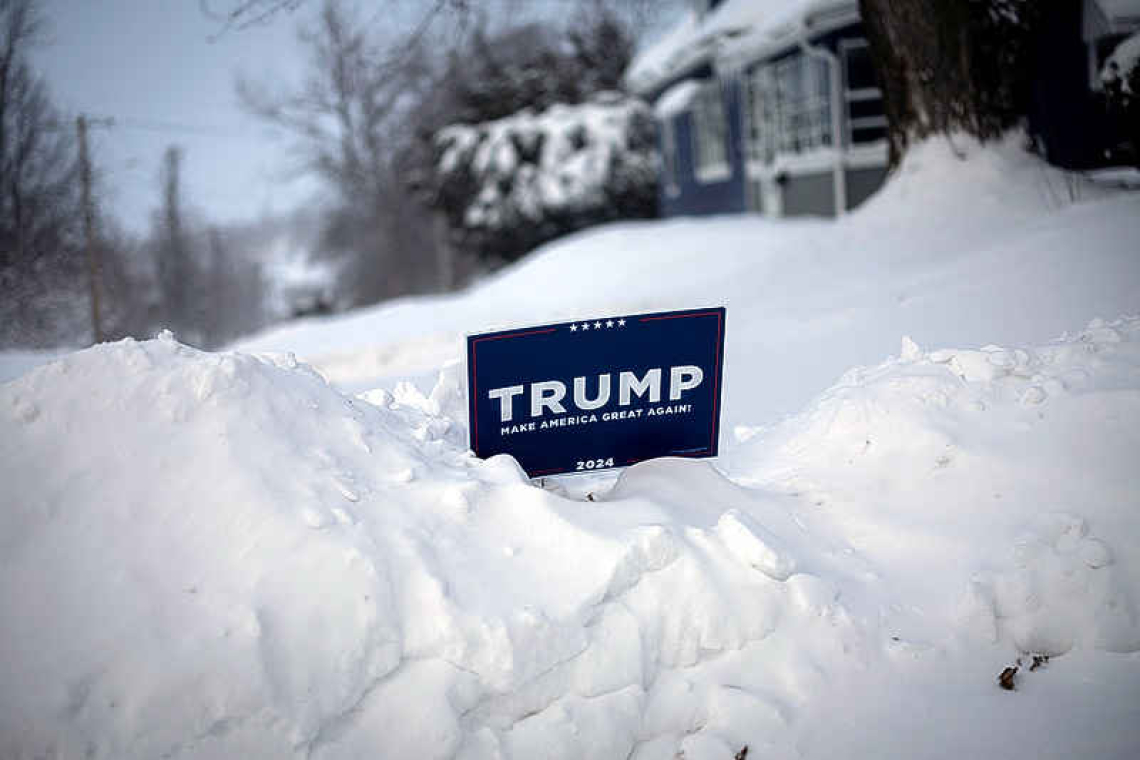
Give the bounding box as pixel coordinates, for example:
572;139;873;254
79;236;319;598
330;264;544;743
0;142;1140;760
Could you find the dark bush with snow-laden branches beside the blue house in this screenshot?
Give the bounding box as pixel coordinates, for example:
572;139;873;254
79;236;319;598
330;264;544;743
435;92;657;263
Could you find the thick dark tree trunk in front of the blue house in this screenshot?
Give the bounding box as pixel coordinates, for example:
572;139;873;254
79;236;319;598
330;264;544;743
860;0;1049;166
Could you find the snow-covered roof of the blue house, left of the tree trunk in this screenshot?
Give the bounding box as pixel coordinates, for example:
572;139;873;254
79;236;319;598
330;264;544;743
626;0;857;93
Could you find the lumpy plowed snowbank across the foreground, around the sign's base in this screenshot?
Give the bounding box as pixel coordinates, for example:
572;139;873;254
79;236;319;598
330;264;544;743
0;319;1140;759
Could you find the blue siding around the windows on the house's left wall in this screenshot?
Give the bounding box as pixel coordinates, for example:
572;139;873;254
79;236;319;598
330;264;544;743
660;83;746;216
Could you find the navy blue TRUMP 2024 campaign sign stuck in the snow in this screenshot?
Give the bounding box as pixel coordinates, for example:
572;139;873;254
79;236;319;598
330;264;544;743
467;308;725;477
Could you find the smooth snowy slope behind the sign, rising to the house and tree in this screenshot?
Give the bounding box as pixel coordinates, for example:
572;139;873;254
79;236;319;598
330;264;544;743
235;136;1140;430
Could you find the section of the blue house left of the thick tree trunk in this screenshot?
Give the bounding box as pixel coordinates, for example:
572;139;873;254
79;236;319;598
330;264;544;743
626;0;887;216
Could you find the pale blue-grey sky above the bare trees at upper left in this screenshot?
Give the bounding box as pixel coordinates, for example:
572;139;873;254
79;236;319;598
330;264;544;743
35;0;676;231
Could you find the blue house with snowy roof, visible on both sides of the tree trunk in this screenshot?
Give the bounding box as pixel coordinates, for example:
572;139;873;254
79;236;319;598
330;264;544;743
626;0;1140;216
